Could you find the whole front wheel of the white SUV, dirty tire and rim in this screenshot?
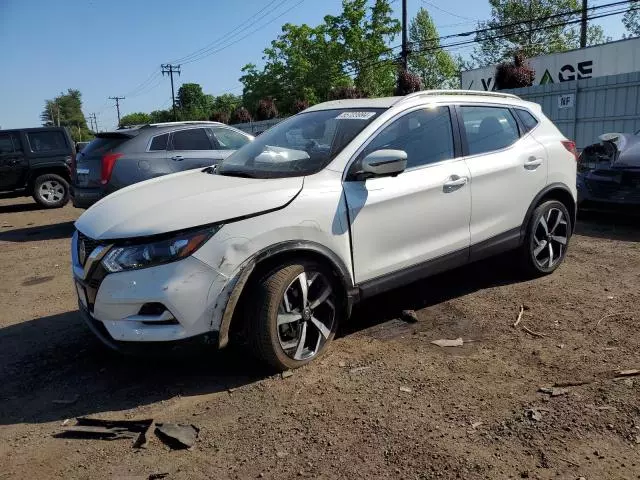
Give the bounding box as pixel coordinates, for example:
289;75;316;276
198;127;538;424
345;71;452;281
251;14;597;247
247;261;344;371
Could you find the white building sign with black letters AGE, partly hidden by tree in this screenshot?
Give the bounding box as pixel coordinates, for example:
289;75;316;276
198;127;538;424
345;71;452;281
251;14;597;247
461;38;640;91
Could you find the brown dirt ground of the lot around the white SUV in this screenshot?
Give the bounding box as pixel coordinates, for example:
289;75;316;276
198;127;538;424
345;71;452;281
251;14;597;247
0;199;640;479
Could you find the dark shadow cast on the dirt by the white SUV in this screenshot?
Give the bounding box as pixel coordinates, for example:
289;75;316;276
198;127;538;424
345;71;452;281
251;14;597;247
0;255;517;425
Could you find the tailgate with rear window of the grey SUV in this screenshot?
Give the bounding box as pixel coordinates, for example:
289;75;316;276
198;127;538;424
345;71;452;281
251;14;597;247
72;132;131;188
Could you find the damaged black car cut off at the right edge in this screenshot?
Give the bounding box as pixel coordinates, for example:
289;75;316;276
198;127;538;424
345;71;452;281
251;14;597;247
577;131;640;208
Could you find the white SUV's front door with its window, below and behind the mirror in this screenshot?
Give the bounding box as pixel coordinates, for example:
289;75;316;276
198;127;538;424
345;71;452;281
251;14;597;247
344;107;471;283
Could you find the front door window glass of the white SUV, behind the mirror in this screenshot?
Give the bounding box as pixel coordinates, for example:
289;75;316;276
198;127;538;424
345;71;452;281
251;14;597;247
362;107;454;168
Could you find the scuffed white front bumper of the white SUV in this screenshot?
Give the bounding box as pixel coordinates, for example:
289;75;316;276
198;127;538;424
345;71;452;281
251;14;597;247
72;233;227;347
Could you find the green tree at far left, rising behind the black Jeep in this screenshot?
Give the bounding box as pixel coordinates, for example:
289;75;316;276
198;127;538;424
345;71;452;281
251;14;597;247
40;88;93;142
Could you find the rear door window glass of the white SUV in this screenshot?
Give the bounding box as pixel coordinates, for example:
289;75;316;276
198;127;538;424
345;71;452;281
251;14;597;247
460;107;520;155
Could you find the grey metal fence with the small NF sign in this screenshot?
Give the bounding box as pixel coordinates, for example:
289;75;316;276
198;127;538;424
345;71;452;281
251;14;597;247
510;72;640;149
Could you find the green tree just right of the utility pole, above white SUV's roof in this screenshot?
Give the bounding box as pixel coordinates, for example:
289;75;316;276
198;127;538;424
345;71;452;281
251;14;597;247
409;8;460;89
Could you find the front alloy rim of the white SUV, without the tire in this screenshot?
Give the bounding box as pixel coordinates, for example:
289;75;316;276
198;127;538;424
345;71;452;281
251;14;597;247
277;271;336;361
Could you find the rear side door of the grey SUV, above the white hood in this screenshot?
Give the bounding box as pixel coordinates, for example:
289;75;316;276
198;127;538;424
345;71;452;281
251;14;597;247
169;127;221;172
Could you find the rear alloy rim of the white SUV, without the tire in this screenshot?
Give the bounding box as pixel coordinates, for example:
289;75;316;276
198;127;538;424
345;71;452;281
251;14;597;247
532;208;569;270
